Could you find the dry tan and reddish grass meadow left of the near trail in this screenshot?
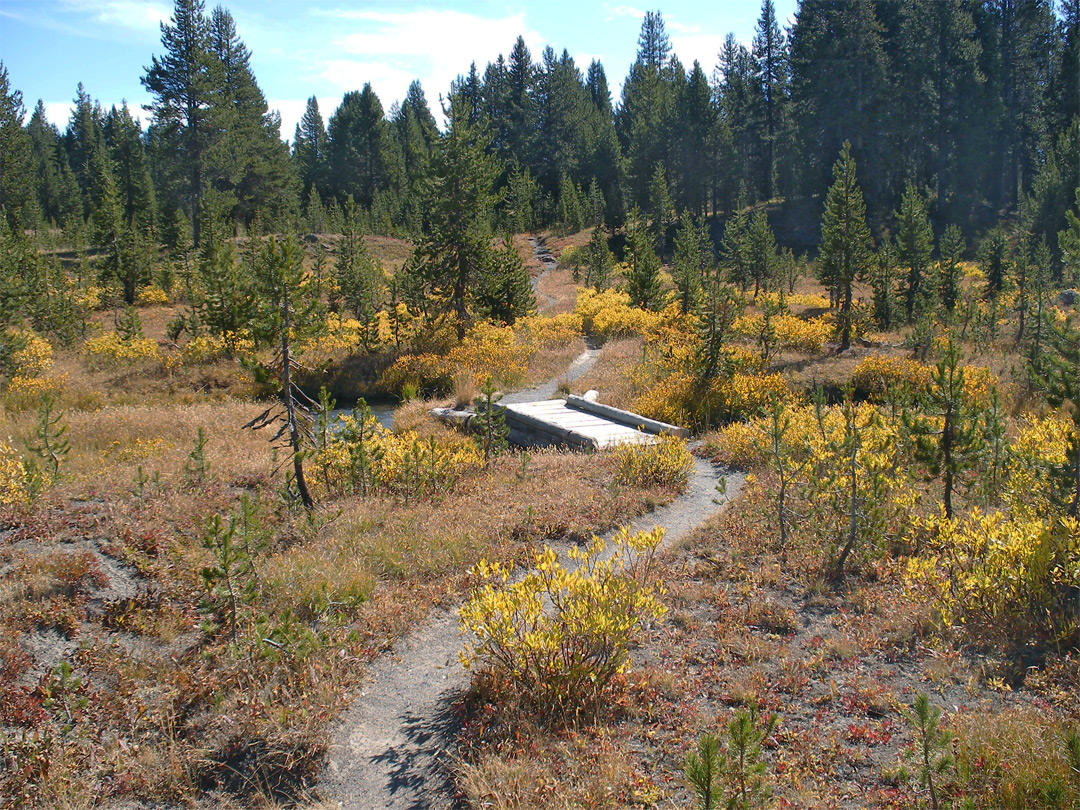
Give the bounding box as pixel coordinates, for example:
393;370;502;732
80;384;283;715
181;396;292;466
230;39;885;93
0;371;654;807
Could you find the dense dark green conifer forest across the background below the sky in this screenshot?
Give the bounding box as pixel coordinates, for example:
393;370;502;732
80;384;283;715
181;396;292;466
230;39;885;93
0;0;1080;260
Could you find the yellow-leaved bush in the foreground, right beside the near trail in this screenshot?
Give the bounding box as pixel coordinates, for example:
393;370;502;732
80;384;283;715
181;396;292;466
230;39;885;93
460;528;666;715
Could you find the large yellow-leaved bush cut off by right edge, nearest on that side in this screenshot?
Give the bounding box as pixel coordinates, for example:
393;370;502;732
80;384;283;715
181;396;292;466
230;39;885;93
907;510;1080;648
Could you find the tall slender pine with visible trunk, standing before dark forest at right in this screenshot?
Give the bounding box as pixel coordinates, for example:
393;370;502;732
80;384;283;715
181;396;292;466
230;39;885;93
819;143;872;351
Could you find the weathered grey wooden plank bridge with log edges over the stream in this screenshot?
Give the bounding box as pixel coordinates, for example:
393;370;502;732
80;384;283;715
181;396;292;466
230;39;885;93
431;392;689;449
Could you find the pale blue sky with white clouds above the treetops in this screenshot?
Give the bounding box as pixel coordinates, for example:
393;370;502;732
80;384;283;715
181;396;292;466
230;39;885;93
0;0;796;138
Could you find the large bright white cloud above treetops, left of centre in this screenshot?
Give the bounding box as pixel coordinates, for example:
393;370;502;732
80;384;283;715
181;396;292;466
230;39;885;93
318;9;543;116
